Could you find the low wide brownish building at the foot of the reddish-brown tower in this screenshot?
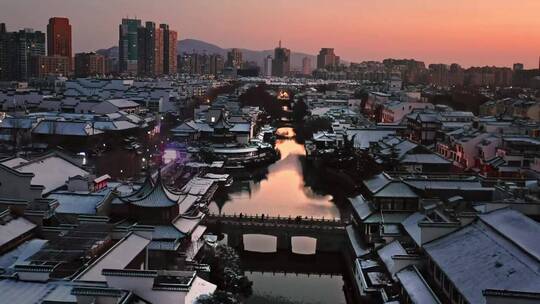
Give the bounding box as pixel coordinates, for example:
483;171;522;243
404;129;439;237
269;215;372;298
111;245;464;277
29;55;71;78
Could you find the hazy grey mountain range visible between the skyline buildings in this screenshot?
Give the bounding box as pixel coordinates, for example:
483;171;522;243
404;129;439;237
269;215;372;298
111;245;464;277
96;39;317;70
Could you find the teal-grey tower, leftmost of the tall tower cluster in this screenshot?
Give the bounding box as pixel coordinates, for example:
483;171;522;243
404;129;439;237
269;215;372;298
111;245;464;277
118;19;141;74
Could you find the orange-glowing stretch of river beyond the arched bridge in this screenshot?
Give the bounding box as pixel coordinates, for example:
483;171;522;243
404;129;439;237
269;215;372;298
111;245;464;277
210;128;340;219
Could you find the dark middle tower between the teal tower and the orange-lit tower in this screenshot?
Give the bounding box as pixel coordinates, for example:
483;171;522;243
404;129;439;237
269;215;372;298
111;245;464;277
137;21;164;76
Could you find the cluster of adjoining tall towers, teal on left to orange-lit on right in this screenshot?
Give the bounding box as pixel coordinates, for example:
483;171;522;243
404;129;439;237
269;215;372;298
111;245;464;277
118;18;178;76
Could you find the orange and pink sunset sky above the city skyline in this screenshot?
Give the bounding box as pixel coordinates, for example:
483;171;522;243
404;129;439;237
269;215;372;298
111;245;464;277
0;0;540;68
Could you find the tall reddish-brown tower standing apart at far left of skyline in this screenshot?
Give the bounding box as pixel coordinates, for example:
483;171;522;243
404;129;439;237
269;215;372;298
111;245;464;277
47;17;71;58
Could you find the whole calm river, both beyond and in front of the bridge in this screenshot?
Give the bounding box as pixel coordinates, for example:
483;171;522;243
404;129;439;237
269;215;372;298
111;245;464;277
210;128;352;304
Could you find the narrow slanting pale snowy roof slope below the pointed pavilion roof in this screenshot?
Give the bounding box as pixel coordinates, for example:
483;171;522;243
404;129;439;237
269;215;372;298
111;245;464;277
76;233;150;282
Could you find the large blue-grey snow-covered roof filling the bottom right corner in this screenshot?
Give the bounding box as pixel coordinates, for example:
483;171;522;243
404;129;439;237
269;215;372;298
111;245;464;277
424;209;540;304
